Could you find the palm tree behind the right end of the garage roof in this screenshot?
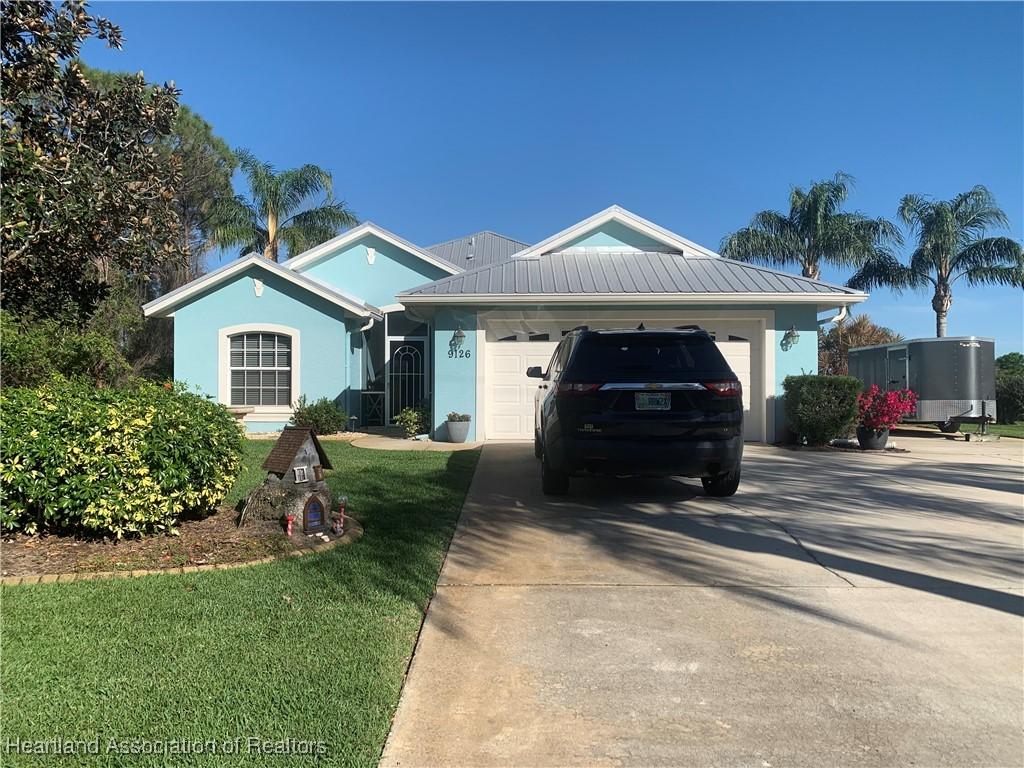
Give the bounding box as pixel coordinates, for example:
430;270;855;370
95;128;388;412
721;172;899;280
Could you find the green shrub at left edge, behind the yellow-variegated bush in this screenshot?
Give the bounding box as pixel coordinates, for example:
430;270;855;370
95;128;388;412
0;313;132;387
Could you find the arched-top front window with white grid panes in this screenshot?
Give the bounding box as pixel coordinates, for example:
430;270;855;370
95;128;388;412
230;333;292;406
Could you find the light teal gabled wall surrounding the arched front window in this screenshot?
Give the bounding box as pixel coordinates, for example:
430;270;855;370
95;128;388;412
174;267;359;431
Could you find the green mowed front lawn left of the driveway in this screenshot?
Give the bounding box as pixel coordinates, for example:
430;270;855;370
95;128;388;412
0;440;478;766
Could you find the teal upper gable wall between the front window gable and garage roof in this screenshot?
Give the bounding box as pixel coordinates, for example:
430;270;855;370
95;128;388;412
298;234;449;307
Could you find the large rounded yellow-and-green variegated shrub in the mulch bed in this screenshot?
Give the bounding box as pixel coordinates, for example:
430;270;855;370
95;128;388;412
0;381;243;538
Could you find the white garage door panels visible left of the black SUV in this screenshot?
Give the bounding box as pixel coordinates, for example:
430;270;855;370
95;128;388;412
484;341;558;440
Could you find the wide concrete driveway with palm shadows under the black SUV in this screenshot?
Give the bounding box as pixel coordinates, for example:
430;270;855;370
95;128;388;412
382;438;1024;768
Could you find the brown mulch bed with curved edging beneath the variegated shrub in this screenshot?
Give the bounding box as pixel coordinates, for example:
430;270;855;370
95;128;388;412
0;507;348;577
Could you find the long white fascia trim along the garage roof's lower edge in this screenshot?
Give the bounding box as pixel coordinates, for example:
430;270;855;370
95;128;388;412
398;293;867;306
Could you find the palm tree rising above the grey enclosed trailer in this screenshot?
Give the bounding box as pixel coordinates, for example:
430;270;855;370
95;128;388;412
849;184;1024;337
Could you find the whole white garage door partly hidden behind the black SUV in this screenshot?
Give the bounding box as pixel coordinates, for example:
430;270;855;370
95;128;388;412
482;321;764;441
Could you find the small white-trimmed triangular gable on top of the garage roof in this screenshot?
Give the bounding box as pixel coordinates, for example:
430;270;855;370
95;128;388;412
516;206;718;258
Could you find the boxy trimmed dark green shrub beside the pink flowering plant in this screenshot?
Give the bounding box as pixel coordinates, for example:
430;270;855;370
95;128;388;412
782;376;862;445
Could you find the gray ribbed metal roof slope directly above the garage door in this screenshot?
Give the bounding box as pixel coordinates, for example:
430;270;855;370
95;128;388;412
399;252;863;298
